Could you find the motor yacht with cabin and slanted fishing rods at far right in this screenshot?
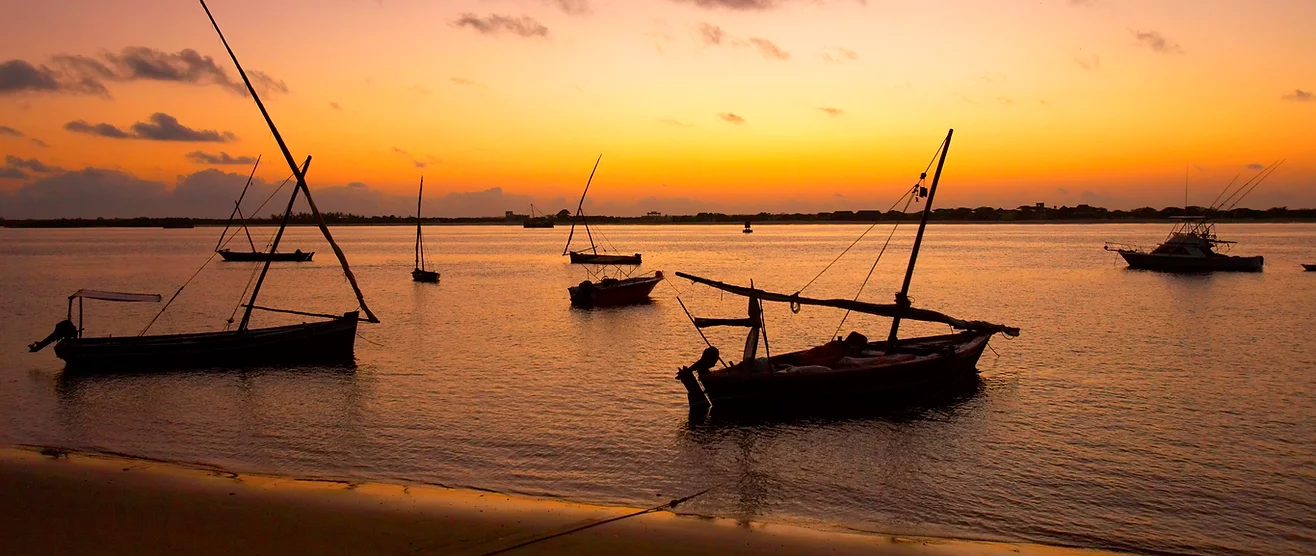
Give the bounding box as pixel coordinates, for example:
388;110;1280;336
1104;161;1283;273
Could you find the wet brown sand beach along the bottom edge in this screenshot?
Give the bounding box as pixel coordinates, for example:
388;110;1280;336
0;448;1126;556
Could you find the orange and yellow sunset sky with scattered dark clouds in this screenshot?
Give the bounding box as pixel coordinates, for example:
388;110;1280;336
0;0;1316;217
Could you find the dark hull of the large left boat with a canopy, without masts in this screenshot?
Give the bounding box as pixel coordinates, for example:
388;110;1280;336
55;311;358;372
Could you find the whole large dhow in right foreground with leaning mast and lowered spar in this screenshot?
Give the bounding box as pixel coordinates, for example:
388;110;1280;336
676;130;1019;410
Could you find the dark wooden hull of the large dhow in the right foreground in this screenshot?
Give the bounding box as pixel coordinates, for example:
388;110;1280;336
697;332;992;408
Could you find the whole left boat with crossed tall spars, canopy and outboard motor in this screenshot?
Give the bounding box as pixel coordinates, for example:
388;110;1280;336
29;0;379;372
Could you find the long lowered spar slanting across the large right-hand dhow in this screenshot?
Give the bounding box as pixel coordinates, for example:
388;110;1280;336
676;273;1019;336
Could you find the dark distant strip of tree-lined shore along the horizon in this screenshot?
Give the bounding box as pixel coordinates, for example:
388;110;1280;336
0;204;1316;228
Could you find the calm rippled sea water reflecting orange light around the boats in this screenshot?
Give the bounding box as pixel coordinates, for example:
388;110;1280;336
0;224;1316;555
